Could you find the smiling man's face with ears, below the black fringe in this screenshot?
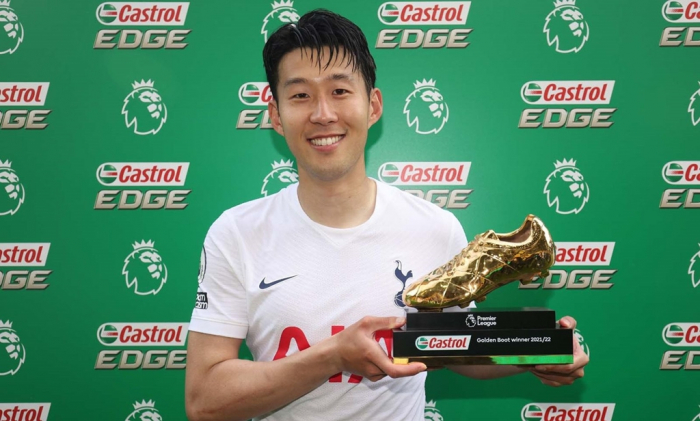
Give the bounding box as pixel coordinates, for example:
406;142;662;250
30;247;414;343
268;48;382;181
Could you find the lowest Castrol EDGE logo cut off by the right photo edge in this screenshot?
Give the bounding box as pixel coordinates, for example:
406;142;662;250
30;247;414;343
659;322;700;370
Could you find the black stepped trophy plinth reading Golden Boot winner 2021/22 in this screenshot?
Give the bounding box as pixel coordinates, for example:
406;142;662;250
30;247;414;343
393;307;574;367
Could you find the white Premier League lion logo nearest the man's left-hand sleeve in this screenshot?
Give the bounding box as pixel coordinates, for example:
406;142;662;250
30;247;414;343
122;240;168;295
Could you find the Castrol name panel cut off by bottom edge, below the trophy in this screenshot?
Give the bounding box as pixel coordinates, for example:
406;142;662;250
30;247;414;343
520;403;615;421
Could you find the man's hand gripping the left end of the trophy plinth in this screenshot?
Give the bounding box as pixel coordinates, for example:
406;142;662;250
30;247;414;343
329;316;426;382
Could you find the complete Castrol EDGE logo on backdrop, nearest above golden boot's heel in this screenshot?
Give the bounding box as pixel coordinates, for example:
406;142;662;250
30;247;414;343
518;80;617;129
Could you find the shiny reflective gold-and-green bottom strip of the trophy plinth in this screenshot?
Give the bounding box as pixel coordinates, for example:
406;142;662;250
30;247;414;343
394;355;574;367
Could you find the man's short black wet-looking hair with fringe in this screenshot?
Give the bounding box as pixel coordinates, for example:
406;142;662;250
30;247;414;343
263;9;377;99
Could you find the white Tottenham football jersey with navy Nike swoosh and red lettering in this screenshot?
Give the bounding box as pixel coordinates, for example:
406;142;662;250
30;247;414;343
190;181;467;421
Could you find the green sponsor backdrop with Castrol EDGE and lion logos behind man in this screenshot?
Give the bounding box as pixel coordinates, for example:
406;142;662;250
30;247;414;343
0;0;700;421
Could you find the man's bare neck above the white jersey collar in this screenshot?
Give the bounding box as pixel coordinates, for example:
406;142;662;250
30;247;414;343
297;172;377;228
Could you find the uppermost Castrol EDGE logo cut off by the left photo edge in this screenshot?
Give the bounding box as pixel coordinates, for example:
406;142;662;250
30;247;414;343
0;81;51;130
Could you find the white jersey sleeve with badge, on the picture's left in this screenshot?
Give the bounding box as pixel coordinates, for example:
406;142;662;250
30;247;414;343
189;213;248;339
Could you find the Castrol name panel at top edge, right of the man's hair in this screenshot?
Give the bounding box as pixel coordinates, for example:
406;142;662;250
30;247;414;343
377;1;471;25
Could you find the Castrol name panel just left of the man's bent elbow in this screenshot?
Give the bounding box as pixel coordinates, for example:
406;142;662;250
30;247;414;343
97;323;189;346
